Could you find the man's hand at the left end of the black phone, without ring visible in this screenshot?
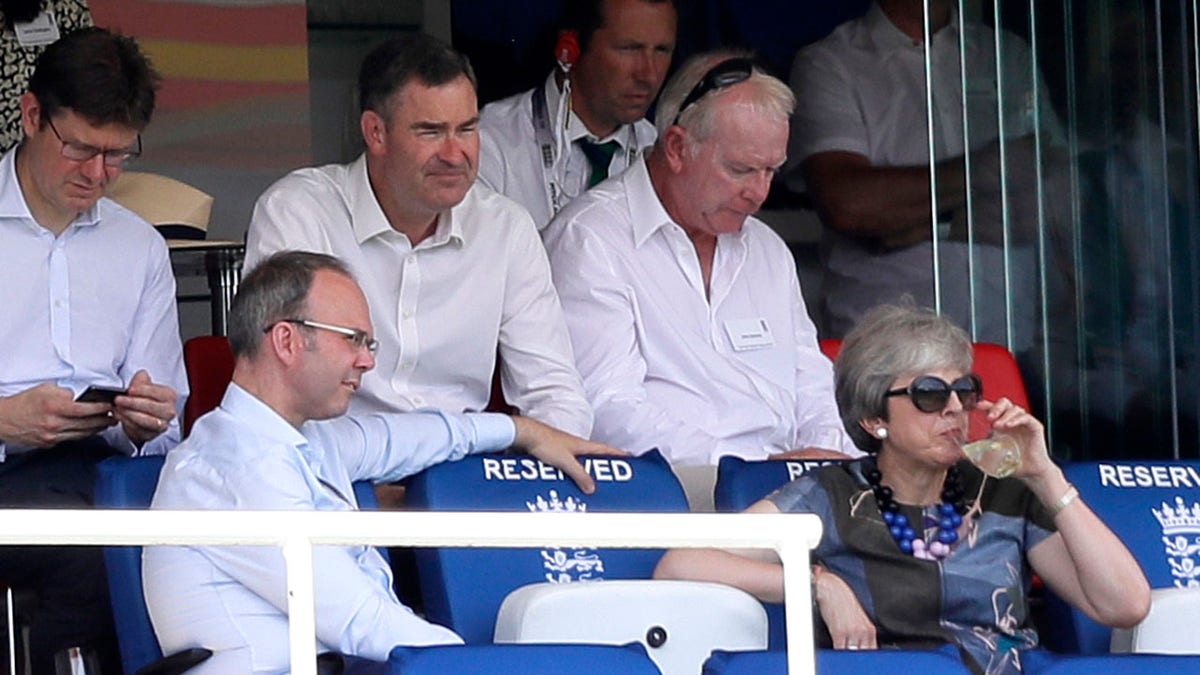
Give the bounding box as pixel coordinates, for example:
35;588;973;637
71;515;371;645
0;382;116;448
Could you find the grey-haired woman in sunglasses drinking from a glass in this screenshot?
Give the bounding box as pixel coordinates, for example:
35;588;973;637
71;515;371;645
655;306;1150;674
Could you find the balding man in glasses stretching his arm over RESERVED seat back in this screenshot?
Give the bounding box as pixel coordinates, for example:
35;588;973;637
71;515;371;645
143;251;614;675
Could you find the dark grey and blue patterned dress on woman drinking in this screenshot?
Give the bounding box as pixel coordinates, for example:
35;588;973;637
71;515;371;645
767;458;1055;675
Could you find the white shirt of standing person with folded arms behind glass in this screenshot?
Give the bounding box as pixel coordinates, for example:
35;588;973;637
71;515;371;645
788;4;1052;350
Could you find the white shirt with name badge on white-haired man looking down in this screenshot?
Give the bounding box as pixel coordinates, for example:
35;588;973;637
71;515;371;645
545;160;860;465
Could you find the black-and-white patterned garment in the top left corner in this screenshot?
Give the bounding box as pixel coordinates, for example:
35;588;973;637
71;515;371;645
0;0;91;153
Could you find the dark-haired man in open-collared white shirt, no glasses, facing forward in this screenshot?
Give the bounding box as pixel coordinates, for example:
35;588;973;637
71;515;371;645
246;34;592;437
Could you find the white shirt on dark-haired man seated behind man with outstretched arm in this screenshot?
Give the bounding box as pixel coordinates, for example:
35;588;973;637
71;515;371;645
245;157;592;437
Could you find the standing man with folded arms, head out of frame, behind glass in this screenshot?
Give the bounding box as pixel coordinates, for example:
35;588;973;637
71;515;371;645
788;0;1057;341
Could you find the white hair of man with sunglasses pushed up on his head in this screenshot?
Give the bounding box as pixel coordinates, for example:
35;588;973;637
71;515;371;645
654;49;796;142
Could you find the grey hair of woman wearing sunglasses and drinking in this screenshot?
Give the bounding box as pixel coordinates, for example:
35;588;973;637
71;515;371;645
834;304;974;453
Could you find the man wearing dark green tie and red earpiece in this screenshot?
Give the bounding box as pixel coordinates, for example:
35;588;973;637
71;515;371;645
479;0;677;229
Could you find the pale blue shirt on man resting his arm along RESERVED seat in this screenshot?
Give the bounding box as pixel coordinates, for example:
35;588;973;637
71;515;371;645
143;384;516;675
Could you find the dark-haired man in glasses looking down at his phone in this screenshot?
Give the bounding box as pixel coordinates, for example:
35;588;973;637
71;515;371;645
0;29;186;674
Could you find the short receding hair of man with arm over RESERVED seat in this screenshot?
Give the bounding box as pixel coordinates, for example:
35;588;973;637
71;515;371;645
229;251;354;358
